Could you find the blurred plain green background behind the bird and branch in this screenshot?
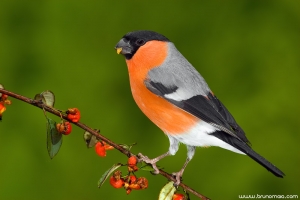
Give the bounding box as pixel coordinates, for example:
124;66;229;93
0;0;300;200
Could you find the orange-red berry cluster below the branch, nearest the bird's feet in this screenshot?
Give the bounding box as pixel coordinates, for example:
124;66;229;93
109;156;148;194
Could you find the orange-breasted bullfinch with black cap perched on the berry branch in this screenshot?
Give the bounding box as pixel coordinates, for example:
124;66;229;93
115;30;285;185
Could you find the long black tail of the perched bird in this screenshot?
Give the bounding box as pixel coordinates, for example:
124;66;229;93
211;131;285;178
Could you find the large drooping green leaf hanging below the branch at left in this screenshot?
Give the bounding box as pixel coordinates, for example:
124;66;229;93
47;118;62;159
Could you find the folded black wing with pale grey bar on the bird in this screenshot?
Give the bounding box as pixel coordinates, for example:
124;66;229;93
144;71;249;143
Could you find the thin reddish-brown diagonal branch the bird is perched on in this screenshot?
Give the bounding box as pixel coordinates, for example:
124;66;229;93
0;88;209;200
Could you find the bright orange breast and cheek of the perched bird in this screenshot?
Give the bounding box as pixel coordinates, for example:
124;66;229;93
126;41;199;134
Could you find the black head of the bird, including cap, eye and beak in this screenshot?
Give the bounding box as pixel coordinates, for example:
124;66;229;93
115;31;170;60
